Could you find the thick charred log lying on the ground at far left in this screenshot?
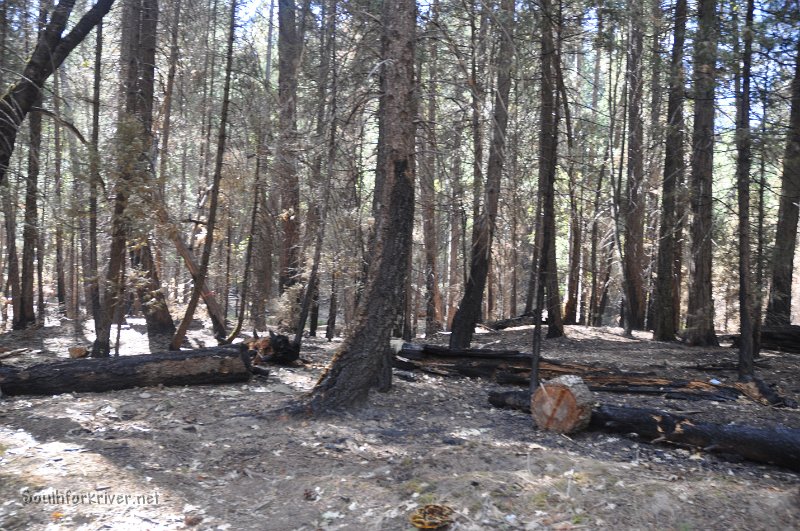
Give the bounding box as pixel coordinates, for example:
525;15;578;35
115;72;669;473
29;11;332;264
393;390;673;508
0;345;252;395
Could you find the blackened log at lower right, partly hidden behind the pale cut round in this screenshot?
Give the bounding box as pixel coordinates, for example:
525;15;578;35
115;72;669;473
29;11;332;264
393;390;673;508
489;391;800;470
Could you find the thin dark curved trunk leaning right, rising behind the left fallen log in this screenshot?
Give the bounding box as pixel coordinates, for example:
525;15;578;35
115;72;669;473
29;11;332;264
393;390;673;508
170;0;236;350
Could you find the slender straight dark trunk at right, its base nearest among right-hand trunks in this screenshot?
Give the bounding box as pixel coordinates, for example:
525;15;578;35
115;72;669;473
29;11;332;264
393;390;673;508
736;0;755;381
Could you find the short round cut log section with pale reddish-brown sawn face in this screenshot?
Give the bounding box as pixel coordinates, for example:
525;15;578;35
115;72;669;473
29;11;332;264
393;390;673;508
531;375;593;433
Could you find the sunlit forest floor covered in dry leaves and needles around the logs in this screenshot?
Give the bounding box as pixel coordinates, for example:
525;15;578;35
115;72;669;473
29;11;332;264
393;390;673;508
0;319;800;531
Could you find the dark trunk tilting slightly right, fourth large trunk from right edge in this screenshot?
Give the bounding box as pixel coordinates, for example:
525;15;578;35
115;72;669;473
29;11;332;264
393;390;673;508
653;0;687;341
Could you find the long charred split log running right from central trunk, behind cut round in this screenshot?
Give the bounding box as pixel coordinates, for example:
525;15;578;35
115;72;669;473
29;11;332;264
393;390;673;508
395;343;756;403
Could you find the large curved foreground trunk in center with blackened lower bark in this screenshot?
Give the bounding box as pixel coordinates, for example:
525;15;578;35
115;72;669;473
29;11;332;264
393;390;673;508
306;0;417;415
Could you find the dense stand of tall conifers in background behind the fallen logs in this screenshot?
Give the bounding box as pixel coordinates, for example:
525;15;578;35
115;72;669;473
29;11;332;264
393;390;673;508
0;0;800;366
